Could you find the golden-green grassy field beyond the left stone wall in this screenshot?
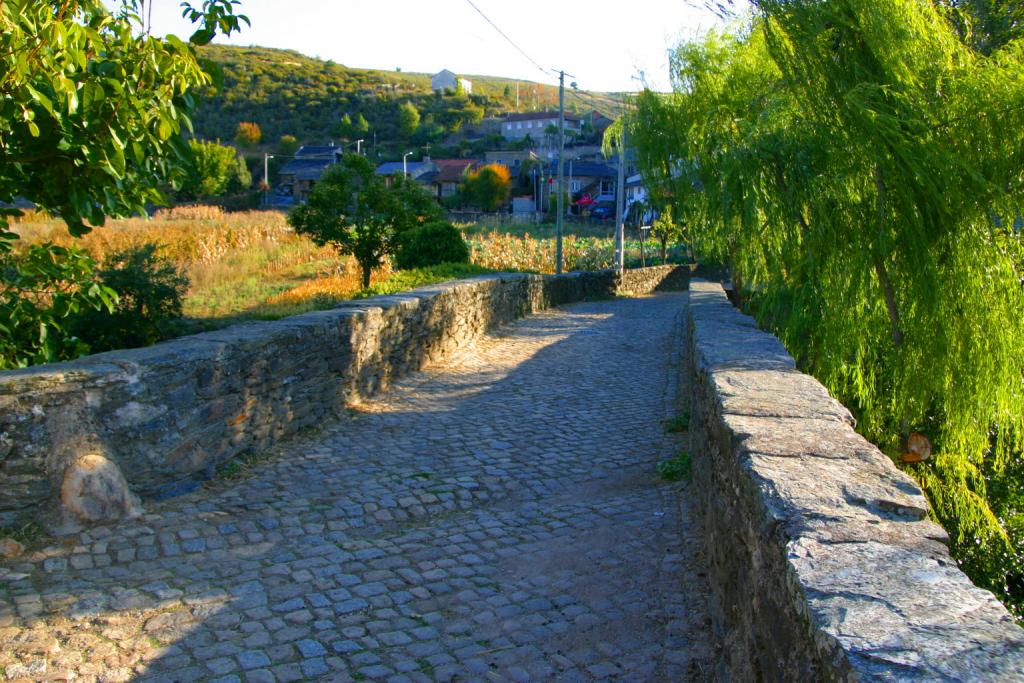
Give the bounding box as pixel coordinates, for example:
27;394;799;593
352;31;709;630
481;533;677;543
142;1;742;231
13;207;679;332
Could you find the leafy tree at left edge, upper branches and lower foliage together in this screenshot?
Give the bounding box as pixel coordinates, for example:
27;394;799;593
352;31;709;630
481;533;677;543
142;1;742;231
0;0;248;367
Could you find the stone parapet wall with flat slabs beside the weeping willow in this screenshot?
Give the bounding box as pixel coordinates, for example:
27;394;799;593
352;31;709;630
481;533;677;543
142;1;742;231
689;281;1024;681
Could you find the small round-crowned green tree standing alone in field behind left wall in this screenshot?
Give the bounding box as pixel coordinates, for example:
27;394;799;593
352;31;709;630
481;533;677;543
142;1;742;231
288;155;440;287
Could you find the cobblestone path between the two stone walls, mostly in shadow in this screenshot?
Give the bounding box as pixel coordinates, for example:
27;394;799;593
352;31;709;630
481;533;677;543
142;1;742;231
0;294;710;682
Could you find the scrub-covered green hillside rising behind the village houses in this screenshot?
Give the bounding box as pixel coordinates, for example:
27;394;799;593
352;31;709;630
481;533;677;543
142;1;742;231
195;45;620;154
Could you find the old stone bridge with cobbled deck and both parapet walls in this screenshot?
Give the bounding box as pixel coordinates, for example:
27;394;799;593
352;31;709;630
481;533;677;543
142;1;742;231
0;267;1024;682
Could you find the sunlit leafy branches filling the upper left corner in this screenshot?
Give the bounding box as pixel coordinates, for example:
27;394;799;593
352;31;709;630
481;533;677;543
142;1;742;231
0;0;244;241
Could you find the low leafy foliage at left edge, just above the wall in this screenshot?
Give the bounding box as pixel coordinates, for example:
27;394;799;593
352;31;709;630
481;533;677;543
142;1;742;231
0;243;117;369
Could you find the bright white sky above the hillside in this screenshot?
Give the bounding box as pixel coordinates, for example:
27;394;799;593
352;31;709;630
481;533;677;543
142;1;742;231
140;0;733;91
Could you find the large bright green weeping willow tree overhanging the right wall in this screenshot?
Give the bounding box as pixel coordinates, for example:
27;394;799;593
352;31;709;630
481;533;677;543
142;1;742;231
628;0;1024;613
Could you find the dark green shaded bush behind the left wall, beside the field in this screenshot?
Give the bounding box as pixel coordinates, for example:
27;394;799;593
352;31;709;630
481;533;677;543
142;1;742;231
72;244;188;353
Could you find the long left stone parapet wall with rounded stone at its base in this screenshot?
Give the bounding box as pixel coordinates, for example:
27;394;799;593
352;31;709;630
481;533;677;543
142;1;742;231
0;266;689;526
